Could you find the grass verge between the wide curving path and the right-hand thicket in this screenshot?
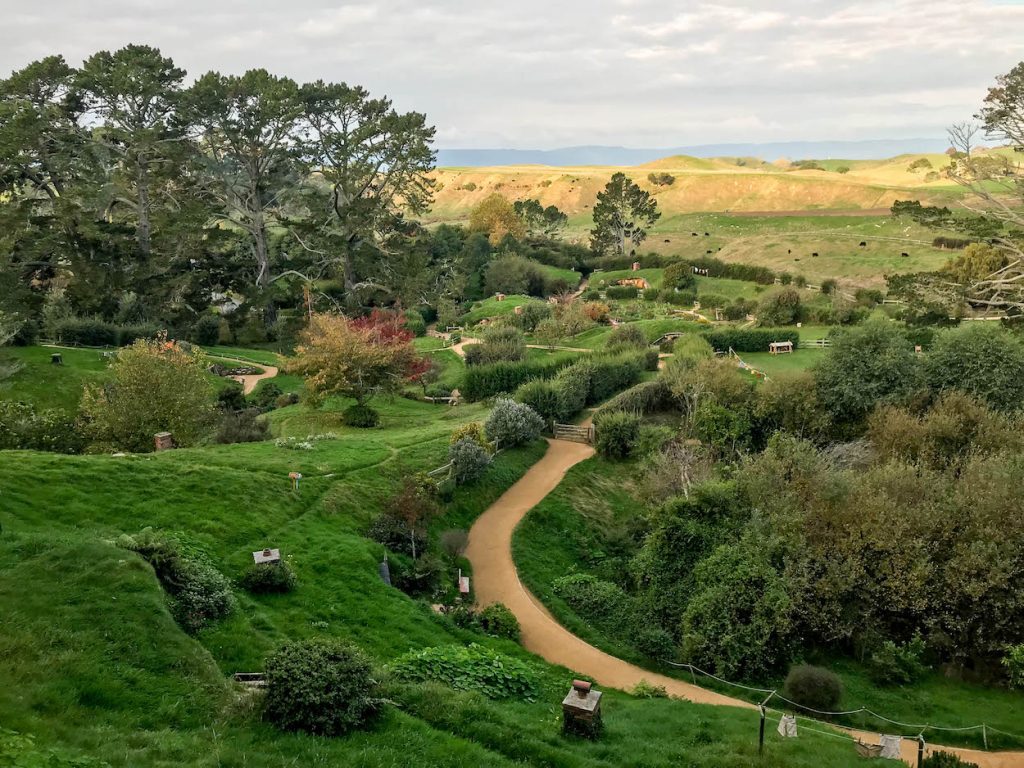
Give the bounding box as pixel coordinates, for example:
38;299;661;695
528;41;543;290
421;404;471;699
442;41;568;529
513;456;1024;753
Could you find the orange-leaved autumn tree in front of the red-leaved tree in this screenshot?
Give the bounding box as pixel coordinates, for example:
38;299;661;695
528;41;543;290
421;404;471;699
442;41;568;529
287;309;429;426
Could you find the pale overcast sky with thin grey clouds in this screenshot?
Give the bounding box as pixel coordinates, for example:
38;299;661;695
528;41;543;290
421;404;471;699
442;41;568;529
0;0;1024;148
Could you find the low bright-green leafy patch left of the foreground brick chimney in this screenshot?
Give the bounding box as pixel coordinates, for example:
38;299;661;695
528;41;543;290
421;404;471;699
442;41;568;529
391;643;541;701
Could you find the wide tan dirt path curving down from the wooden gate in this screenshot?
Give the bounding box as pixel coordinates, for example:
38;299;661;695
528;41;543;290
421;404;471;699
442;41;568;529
466;439;1024;768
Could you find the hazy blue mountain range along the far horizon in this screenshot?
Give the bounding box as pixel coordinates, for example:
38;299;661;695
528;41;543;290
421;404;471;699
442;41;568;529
437;138;949;168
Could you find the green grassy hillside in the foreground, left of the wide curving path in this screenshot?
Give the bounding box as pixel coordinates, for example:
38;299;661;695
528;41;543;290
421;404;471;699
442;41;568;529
0;399;897;768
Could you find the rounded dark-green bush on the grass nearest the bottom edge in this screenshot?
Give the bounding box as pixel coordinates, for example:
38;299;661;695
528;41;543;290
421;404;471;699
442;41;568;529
264;639;380;736
